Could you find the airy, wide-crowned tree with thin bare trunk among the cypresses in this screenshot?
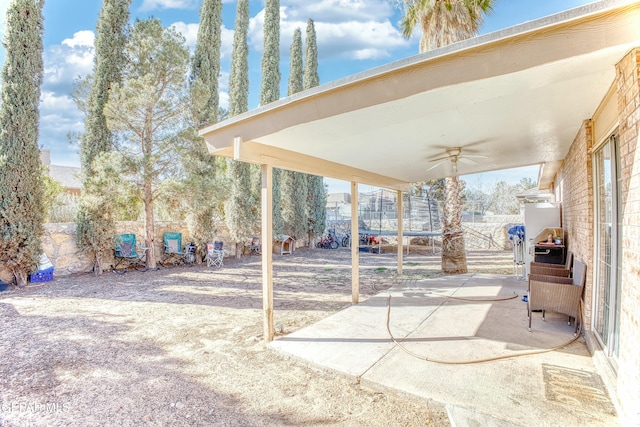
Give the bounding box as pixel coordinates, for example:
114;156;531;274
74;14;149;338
104;18;192;269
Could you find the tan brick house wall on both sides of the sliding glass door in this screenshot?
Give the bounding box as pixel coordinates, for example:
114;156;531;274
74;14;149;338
555;48;640;425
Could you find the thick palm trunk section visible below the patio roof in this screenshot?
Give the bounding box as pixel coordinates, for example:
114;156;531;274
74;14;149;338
442;176;468;274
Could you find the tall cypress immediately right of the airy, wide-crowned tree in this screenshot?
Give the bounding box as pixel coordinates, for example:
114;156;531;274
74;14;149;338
183;0;226;262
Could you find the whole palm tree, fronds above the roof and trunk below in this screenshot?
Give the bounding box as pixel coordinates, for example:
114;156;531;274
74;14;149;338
395;0;493;274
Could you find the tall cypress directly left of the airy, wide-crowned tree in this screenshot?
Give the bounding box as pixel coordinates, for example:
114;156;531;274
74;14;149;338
76;0;131;274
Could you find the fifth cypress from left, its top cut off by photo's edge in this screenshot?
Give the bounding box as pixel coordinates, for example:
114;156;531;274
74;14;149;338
260;0;284;235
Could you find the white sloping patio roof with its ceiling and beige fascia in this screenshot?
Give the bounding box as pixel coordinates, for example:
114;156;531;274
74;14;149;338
200;1;640;189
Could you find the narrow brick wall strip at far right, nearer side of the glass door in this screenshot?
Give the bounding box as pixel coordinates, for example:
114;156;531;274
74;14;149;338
616;48;640;425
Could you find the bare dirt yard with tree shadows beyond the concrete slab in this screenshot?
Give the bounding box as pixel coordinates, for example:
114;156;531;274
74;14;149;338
0;247;513;426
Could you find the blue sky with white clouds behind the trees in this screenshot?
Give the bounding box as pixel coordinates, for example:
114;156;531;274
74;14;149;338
0;0;593;191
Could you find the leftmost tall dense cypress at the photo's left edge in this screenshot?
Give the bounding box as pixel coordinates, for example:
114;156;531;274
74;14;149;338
0;0;45;287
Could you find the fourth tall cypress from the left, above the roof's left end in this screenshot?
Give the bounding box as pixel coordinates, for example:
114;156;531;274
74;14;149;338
225;0;260;257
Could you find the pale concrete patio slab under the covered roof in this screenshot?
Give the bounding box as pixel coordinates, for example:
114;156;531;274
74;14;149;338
270;274;618;426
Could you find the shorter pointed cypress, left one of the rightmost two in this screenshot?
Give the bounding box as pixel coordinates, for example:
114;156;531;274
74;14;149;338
281;28;308;239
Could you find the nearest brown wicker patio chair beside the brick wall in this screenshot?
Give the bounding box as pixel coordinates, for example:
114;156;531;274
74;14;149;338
527;260;587;335
